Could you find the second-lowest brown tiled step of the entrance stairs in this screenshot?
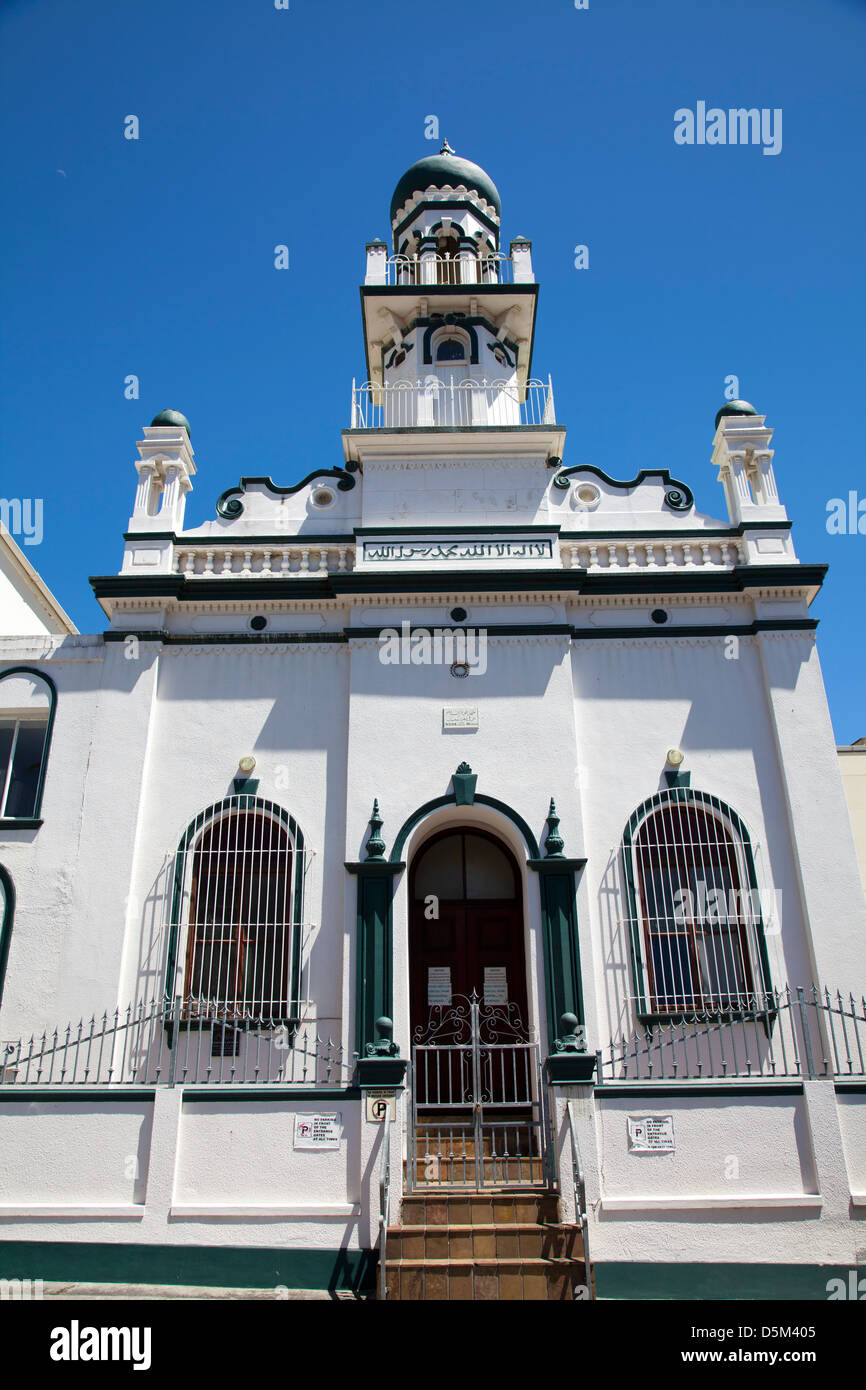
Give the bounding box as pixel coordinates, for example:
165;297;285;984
388;1222;584;1264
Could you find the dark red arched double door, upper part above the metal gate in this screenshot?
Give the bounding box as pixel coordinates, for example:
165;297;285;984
409;827;527;1036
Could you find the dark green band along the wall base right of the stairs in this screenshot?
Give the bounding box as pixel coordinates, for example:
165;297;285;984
592;1261;852;1301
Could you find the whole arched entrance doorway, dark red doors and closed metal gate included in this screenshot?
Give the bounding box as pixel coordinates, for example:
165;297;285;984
406;826;550;1191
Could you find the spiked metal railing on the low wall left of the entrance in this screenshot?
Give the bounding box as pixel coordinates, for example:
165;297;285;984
0;995;353;1091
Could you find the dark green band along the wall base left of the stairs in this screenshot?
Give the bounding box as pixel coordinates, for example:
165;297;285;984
0;1251;377;1291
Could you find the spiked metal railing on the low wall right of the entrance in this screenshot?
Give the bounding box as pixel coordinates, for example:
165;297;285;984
598;986;866;1081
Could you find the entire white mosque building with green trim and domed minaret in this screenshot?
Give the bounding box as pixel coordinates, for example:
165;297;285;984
0;145;866;1301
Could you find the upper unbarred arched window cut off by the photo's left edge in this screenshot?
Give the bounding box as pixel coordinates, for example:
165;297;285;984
0;666;57;827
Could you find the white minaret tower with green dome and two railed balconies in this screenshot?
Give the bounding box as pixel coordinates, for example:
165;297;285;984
352;140;553;428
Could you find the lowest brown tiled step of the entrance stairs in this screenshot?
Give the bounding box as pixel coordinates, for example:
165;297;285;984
386;1259;585;1302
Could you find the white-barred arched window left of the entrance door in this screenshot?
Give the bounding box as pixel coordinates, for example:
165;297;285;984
170;795;303;1022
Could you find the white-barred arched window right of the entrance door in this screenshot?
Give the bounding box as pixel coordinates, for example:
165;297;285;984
623;788;769;1016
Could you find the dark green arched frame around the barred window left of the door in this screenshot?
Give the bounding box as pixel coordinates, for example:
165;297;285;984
164;794;306;1023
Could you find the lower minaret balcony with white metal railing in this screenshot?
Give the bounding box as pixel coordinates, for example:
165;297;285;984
350;375;556;430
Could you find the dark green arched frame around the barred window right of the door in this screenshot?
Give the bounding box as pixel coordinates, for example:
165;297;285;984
621;787;774;1023
